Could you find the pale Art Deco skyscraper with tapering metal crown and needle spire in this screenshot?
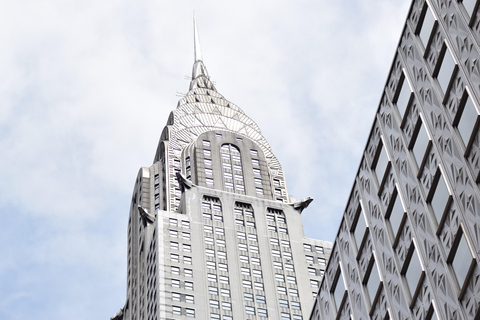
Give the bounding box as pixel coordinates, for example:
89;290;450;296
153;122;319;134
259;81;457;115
112;21;331;320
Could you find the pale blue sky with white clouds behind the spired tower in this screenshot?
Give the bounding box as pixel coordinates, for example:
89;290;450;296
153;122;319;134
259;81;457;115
0;0;409;320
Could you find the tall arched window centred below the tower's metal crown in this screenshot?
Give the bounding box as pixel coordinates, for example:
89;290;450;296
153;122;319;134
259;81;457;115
220;143;245;194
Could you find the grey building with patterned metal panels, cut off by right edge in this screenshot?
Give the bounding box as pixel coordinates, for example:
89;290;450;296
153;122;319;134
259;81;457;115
310;0;480;320
